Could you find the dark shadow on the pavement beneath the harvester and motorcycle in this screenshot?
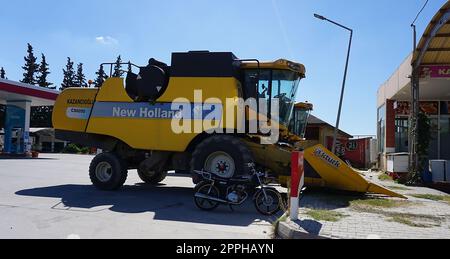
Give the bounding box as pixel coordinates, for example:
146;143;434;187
16;185;281;226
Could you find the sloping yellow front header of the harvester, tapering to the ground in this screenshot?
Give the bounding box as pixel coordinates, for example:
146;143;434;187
305;145;406;199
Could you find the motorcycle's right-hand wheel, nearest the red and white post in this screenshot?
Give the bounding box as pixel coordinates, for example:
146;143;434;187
254;189;283;216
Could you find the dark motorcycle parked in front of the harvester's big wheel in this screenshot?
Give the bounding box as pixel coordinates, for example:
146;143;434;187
194;163;285;216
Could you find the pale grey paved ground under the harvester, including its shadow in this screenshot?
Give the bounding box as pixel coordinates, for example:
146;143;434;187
0;155;274;239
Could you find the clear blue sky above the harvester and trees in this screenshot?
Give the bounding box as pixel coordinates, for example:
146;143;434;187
0;0;446;135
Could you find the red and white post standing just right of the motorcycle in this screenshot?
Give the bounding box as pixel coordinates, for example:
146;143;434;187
290;151;305;221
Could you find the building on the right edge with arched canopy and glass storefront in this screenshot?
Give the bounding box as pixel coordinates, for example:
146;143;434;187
377;2;450;172
